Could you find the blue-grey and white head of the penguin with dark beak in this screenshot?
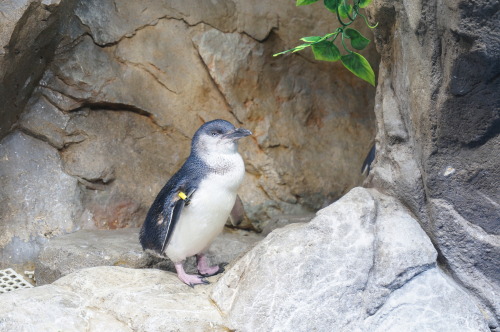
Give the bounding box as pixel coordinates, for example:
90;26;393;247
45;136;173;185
191;120;252;154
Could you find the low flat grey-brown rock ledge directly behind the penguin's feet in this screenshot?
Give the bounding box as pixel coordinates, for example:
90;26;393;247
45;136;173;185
35;228;262;285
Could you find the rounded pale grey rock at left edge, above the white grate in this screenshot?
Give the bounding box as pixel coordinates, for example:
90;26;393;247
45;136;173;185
0;131;81;270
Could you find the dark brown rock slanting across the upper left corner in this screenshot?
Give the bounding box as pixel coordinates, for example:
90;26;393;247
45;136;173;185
0;0;63;138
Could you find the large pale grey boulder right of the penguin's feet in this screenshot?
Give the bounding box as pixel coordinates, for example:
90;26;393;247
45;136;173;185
211;188;488;331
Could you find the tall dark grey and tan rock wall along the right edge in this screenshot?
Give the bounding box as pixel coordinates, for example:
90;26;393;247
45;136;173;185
368;0;500;331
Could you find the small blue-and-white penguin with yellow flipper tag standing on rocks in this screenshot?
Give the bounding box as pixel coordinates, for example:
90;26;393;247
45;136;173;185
139;119;252;287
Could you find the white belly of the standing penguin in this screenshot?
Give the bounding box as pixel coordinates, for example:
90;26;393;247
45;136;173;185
165;168;244;262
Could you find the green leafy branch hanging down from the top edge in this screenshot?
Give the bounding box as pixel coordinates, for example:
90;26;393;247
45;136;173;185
273;0;378;86
